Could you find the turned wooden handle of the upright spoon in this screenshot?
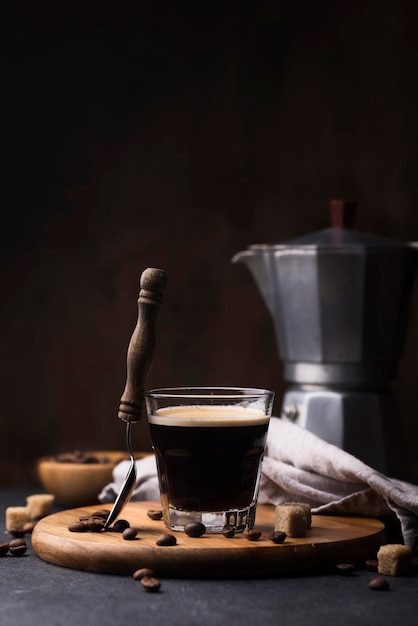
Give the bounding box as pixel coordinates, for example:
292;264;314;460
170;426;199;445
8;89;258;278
118;267;167;422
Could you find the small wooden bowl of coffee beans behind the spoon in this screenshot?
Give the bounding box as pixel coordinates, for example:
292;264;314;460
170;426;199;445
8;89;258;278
36;451;133;508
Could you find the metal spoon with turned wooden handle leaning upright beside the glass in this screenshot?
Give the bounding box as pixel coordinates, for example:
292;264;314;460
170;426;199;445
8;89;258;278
105;268;167;530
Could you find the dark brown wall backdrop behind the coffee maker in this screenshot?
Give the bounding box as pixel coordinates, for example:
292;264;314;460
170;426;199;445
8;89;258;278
0;0;418;486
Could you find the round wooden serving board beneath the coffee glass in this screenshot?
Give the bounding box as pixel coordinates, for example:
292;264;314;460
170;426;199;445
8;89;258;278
32;502;384;578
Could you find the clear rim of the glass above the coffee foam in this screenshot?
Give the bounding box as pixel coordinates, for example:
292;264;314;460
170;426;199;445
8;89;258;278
144;386;274;400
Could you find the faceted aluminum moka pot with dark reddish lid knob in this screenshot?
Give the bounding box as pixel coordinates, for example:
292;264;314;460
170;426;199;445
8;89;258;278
232;199;417;478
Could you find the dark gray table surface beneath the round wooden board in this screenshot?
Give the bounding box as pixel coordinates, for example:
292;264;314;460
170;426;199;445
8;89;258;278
0;490;418;626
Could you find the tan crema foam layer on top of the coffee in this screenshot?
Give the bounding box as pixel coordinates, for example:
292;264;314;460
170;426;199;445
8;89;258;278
148;405;269;428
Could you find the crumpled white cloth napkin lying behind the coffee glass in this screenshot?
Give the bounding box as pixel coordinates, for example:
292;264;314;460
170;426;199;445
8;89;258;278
99;417;418;549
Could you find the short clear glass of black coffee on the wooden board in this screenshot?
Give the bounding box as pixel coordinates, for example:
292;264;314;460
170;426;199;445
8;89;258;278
145;387;274;533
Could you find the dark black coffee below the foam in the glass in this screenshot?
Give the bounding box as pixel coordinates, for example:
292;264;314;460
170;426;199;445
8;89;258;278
150;422;268;512
